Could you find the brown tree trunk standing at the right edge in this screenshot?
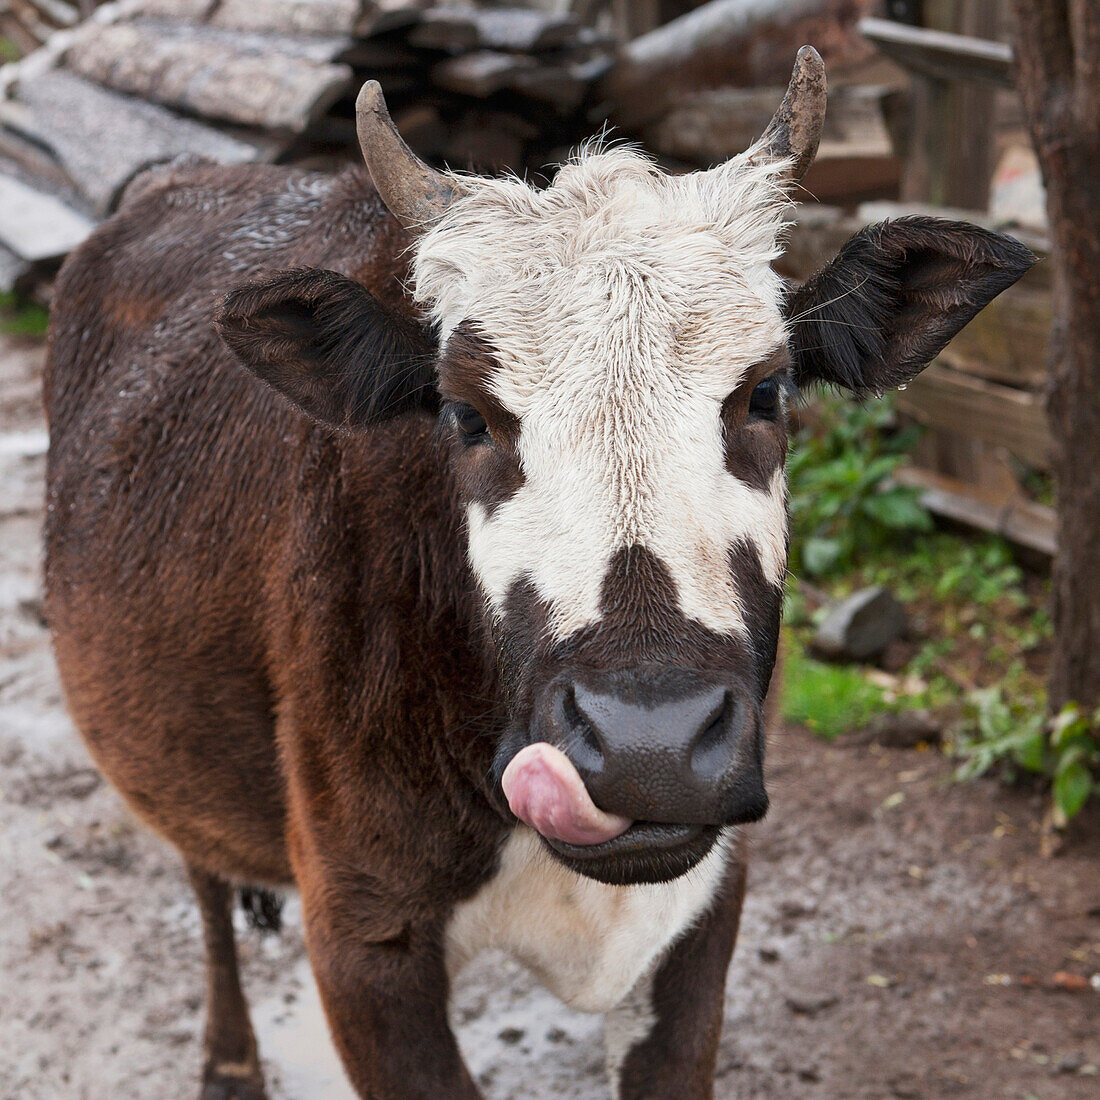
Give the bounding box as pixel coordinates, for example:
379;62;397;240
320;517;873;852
1015;0;1100;708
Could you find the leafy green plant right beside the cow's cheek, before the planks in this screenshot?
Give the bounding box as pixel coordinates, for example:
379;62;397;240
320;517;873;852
788;397;933;576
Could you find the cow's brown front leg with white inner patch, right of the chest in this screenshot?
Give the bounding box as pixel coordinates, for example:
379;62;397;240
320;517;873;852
606;857;745;1100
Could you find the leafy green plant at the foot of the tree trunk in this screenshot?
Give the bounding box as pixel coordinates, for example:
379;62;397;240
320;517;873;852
955;688;1100;828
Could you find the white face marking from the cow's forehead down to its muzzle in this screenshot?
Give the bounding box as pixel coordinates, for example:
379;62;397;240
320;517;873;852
414;149;787;637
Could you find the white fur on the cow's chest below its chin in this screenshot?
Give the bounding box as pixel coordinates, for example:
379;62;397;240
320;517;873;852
437;826;729;1012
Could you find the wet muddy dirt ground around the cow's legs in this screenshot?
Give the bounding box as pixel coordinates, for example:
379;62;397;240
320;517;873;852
0;340;1100;1100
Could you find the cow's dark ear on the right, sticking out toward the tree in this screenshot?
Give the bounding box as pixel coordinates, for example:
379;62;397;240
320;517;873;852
788;217;1035;395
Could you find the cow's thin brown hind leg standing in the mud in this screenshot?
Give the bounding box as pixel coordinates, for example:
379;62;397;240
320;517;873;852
187;866;267;1100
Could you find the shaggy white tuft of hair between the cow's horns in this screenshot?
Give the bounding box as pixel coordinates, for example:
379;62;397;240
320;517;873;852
413;141;790;339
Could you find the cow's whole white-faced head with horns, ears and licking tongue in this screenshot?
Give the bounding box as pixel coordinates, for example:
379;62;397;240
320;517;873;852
220;55;1032;882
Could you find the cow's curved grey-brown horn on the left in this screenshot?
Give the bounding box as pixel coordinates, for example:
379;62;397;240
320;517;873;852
355;80;458;233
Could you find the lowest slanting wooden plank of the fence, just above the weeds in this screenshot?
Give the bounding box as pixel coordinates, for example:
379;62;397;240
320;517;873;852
894;466;1057;558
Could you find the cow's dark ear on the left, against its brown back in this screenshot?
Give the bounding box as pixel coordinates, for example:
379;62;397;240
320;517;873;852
215;270;439;430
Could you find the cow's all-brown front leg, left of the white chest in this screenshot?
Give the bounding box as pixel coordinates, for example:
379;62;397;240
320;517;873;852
299;876;481;1100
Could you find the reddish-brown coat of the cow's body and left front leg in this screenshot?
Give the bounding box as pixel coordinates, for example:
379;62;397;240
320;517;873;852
46;167;506;1098
